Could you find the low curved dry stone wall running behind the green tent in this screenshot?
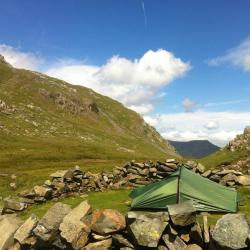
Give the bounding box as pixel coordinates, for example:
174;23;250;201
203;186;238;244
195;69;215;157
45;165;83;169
2;159;250;214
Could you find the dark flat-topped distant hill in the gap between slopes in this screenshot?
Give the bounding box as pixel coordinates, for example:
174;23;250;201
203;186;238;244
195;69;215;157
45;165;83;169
169;140;220;158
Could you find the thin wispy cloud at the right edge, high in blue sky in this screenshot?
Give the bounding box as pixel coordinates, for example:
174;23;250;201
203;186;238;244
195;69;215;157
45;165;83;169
207;37;250;71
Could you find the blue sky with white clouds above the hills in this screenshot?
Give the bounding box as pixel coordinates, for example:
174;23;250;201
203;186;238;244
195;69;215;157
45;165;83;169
0;0;250;145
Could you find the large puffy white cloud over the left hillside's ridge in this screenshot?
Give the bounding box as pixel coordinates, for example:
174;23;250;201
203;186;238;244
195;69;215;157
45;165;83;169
46;49;191;114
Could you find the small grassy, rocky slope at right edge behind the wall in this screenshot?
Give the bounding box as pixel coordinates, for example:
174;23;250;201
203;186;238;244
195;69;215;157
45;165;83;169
201;127;250;171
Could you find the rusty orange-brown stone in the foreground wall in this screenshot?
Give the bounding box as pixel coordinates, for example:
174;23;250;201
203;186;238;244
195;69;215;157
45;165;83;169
91;209;126;234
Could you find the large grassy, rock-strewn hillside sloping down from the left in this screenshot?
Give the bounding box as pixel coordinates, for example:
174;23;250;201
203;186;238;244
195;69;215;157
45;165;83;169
0;56;176;169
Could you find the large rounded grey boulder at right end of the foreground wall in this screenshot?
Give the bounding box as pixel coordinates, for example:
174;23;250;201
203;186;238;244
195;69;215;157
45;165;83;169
212;214;249;250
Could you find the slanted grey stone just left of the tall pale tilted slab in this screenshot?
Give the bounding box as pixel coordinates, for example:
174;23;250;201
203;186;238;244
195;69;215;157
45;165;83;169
33;202;71;242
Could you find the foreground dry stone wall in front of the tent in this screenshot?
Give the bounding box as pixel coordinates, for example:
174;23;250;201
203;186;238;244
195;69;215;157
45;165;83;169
0;201;250;250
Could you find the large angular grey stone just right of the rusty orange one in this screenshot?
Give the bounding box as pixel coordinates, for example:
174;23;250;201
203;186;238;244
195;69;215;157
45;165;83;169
127;212;169;247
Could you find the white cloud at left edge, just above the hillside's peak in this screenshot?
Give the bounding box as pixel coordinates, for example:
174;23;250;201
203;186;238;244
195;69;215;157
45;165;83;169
0;44;44;70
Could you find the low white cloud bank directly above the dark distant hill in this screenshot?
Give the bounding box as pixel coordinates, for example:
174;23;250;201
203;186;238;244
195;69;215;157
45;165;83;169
144;111;250;146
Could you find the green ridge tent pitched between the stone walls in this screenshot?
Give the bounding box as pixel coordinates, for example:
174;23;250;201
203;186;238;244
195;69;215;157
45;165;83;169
130;166;238;212
